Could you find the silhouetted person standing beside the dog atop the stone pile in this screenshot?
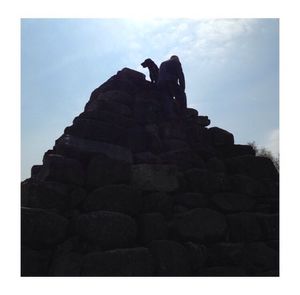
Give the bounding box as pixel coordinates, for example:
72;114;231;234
158;55;186;116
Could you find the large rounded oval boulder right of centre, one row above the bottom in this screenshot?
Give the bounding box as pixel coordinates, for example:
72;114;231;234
173;208;227;242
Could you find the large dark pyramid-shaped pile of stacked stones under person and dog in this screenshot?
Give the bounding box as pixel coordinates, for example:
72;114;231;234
21;68;279;276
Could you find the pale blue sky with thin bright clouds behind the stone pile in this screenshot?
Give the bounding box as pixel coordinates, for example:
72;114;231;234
21;18;279;180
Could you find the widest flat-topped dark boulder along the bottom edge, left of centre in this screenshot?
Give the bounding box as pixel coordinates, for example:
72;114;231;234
81;247;153;276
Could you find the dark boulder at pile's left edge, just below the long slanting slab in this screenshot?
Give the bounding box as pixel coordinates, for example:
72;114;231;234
36;154;84;185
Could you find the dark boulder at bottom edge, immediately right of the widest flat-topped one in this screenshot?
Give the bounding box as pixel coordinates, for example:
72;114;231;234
148;240;191;276
